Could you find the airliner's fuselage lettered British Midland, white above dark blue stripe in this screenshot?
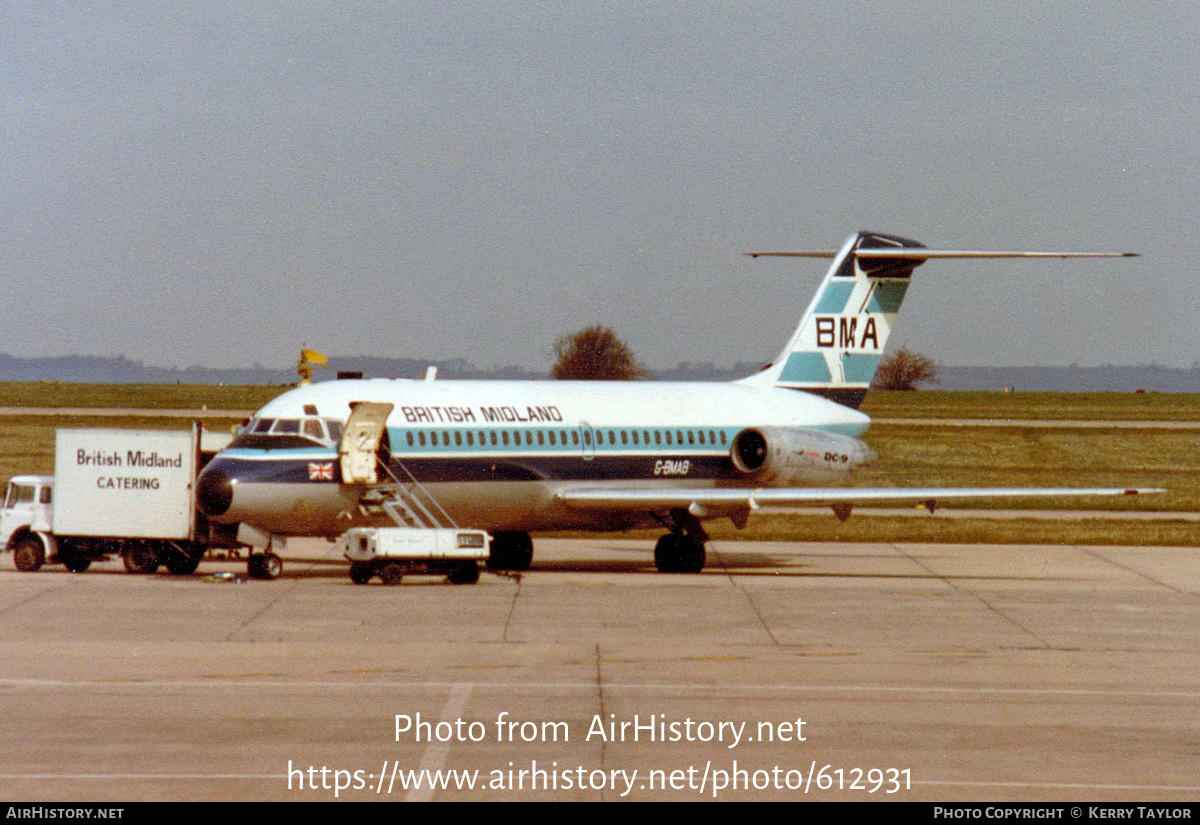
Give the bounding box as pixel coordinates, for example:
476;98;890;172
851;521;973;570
198;379;874;535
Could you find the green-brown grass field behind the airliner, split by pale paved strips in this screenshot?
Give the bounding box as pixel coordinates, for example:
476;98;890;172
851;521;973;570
0;384;1200;544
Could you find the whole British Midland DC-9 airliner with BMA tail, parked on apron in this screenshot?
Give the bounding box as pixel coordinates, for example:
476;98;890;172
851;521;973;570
197;231;1139;577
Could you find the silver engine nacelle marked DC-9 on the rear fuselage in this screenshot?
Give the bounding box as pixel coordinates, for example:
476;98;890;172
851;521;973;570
730;427;878;487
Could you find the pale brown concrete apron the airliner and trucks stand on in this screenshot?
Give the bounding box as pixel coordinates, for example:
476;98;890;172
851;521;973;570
0;540;1200;802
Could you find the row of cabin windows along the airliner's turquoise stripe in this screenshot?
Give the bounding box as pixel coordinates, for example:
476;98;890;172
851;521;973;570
404;428;728;447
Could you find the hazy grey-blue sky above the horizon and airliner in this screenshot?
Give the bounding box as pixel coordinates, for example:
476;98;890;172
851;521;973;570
0;0;1200;368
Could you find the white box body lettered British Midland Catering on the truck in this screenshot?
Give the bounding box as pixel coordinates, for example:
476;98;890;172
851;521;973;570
54;429;198;540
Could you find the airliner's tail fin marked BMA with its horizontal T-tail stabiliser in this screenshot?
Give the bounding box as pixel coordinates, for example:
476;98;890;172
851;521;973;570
743;231;1136;409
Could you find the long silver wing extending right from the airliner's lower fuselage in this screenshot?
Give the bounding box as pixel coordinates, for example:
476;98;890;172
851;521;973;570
558;487;1166;518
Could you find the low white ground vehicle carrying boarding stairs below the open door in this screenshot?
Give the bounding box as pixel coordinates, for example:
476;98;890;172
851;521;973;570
342;528;492;584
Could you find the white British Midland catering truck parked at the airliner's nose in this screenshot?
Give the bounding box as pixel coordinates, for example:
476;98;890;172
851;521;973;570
0;423;253;578
